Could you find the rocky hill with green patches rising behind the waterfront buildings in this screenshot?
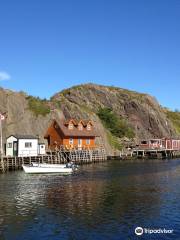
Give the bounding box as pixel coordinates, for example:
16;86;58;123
0;84;180;155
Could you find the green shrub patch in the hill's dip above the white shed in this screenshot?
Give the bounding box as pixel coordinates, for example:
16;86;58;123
26;96;50;116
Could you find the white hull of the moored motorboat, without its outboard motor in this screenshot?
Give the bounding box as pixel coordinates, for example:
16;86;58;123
22;165;73;173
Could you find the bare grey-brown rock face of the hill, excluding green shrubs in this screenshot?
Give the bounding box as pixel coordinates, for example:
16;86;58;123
0;84;176;153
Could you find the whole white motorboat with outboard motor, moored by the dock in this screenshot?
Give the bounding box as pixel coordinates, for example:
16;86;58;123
22;163;77;173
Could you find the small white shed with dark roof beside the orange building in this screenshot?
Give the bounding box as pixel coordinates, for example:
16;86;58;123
6;135;39;157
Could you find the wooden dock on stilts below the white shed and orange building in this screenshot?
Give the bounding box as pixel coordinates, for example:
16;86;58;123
0;148;107;172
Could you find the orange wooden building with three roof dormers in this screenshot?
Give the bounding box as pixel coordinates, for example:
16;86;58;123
44;119;97;150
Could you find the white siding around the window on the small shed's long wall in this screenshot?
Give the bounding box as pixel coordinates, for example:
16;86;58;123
18;139;38;157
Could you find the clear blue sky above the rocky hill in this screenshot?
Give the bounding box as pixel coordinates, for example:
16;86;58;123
0;0;180;109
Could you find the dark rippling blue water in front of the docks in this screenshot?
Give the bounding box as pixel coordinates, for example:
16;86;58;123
0;160;180;240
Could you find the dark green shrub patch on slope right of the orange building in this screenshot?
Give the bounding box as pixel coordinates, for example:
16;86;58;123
97;108;135;138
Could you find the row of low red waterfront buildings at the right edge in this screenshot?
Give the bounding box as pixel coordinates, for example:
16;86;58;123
139;138;180;150
